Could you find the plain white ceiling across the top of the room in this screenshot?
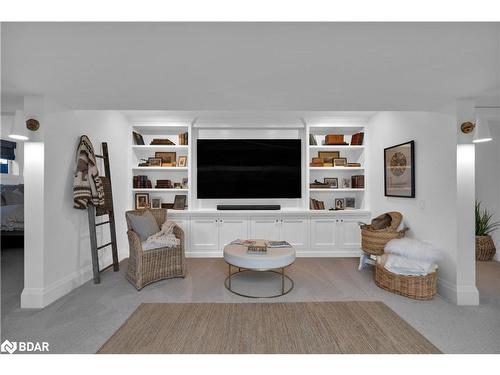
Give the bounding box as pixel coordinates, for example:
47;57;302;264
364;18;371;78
1;23;500;111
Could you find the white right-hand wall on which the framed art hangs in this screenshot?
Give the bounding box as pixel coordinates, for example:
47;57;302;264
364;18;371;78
367;112;473;302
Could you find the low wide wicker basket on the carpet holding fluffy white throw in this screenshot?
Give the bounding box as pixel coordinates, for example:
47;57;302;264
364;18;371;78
375;263;437;300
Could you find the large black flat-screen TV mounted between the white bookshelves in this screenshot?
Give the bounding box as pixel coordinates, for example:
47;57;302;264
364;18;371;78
197;139;302;199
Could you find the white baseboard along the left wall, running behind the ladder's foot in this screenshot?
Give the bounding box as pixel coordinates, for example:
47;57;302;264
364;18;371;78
21;254;119;309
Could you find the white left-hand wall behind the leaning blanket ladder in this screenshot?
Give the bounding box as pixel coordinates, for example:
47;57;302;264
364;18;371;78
24;111;131;307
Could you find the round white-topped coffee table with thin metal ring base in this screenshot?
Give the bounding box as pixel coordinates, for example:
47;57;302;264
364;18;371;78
224;244;295;298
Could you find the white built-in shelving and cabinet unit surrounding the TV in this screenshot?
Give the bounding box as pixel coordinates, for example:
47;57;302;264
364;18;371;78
130;113;370;257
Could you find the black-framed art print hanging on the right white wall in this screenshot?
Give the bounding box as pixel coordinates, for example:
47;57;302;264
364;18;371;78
384;141;415;198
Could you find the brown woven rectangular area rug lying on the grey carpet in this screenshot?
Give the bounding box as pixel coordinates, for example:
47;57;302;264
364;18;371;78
98;301;440;353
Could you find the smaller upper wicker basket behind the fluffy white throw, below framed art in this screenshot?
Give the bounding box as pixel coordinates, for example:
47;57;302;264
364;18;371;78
361;212;409;255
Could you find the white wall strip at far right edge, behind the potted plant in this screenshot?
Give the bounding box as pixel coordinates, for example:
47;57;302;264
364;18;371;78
476;121;500;261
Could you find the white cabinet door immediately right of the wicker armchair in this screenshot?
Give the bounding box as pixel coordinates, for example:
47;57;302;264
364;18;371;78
189;217;219;252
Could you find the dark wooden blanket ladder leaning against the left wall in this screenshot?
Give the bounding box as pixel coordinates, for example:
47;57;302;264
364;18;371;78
87;142;120;284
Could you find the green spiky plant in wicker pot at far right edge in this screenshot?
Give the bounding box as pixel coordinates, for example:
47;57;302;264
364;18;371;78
475;201;500;261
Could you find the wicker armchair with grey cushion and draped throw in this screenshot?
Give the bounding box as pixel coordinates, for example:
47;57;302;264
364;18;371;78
125;209;185;290
